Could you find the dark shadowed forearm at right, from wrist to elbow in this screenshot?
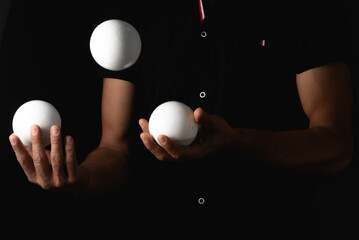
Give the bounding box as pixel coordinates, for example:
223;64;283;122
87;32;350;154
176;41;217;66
233;127;352;174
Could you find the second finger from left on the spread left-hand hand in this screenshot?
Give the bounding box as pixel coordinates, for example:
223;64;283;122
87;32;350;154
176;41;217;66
31;125;51;188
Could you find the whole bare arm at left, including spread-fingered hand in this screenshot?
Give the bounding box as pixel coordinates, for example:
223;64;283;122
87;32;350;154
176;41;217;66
10;79;134;195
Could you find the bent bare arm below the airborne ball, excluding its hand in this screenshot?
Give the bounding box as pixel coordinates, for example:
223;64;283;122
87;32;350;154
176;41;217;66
76;78;134;193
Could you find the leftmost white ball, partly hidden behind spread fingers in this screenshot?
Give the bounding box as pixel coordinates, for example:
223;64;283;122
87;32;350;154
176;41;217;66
12;100;61;147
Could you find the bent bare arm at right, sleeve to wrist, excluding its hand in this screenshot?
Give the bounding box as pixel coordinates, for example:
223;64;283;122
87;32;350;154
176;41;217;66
232;63;353;173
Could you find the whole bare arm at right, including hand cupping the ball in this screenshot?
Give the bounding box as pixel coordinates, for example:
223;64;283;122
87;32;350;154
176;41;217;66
140;63;353;174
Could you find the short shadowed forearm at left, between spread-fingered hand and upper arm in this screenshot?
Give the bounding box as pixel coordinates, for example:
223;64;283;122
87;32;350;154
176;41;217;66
75;147;129;195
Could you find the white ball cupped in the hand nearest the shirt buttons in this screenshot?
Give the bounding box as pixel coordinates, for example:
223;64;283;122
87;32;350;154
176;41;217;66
149;101;198;146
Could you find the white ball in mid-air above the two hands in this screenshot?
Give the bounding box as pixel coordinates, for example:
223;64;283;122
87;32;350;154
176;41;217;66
90;19;141;71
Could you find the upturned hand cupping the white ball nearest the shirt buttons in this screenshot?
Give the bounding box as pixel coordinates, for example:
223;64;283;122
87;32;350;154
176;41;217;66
139;108;234;161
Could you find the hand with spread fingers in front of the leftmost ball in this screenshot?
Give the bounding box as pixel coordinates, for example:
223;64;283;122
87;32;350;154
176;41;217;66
9;125;77;190
